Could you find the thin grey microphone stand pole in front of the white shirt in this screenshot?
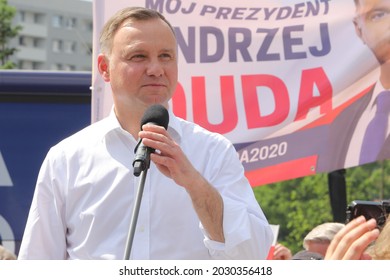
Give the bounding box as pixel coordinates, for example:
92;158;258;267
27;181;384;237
124;168;148;260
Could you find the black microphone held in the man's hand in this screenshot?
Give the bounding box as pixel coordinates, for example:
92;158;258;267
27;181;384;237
133;104;169;177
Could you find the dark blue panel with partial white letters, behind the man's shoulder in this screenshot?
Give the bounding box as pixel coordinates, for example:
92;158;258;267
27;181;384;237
0;102;91;253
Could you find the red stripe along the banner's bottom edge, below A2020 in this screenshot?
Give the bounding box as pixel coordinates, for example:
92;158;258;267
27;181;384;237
245;155;317;187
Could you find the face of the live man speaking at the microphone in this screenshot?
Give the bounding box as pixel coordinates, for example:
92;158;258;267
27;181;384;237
101;19;178;110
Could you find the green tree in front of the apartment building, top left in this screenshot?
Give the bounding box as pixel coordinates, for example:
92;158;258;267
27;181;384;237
0;0;22;69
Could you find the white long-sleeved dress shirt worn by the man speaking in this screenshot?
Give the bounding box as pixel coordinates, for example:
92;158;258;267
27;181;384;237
19;109;273;259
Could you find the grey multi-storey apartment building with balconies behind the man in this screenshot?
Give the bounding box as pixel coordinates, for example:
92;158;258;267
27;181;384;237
8;0;93;71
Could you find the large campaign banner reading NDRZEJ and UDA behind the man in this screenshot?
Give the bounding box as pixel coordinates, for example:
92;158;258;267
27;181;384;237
92;0;390;187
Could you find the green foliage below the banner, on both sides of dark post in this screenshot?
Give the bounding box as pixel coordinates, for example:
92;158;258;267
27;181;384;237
253;161;390;253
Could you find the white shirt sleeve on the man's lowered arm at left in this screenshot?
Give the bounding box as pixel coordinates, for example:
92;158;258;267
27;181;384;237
18;151;66;260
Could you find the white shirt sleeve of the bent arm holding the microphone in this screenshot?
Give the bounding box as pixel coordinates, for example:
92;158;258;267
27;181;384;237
200;141;273;259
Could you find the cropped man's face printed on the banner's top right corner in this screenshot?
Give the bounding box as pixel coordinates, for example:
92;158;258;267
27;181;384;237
354;0;390;64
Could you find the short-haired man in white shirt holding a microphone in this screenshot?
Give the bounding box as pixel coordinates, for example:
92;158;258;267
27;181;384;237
19;8;272;259
